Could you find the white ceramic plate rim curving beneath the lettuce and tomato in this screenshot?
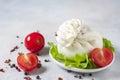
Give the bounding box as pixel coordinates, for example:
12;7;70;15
49;53;115;73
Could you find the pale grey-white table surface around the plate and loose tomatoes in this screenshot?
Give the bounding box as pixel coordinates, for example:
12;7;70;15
0;0;120;80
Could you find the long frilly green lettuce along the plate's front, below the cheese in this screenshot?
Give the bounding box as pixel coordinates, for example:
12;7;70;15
48;42;96;69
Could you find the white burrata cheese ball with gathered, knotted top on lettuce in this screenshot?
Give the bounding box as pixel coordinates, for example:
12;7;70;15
56;19;103;57
